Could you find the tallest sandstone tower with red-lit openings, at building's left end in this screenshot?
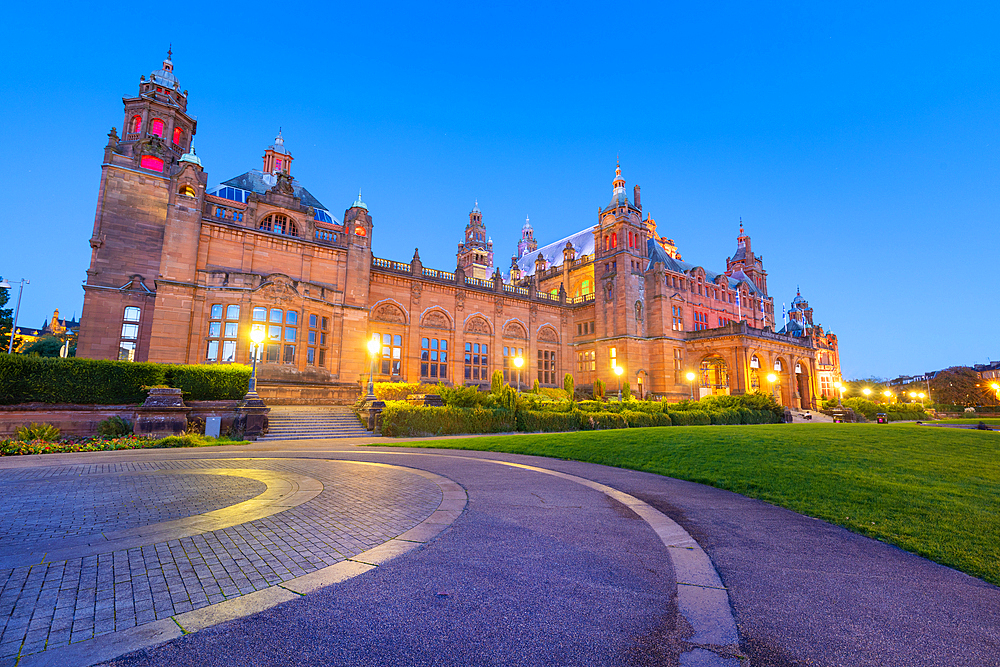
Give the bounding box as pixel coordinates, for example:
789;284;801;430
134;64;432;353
77;51;207;361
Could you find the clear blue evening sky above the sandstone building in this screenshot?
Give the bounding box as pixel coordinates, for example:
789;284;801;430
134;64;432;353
0;2;1000;377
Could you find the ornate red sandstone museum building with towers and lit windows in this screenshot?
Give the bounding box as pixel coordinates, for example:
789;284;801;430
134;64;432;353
77;53;840;408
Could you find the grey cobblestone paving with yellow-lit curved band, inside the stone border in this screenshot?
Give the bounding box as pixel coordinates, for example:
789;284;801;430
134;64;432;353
0;459;441;660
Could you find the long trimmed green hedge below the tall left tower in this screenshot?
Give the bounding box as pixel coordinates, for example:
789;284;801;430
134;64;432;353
0;354;250;405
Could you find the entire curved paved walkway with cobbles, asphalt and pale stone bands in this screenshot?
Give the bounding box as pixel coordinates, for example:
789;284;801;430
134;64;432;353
0;441;1000;667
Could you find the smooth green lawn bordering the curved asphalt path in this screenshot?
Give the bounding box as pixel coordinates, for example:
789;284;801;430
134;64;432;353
376;424;1000;585
